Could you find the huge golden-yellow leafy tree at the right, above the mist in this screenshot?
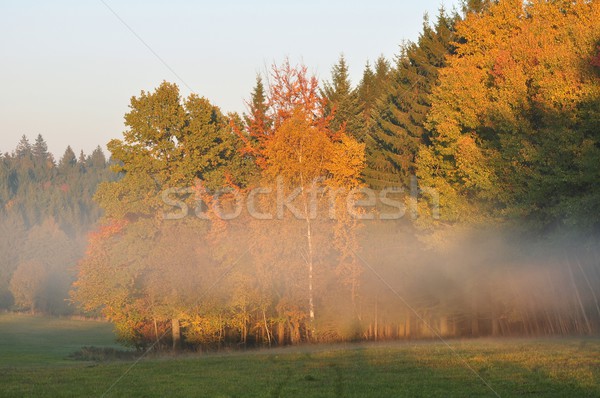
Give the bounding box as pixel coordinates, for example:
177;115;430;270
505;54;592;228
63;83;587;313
417;0;600;228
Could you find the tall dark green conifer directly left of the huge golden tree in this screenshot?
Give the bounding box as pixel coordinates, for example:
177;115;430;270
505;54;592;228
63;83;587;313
365;9;455;188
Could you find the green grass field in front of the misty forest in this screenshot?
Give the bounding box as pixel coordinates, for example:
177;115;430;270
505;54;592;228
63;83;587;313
0;314;600;397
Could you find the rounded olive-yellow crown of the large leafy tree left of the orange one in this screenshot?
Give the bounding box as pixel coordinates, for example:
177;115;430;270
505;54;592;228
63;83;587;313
96;82;243;218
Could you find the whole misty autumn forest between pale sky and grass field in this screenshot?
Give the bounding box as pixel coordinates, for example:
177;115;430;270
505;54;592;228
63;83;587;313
0;0;600;350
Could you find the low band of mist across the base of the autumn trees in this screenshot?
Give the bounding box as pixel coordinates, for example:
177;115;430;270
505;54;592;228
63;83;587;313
74;191;600;349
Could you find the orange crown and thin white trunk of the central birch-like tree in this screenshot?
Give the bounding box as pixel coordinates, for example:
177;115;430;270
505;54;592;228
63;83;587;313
238;61;364;338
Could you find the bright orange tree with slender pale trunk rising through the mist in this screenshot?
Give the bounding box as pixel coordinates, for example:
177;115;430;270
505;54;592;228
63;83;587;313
234;61;365;338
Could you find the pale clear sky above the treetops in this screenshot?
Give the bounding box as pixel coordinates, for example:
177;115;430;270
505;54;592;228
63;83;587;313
0;0;459;159
